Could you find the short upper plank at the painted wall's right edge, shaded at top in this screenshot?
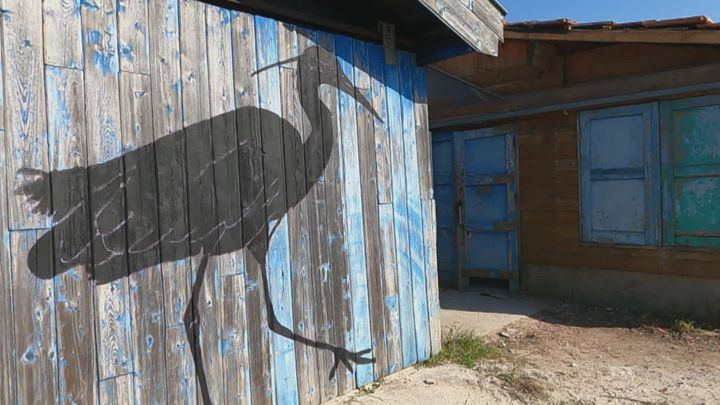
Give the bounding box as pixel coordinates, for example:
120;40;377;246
413;67;433;200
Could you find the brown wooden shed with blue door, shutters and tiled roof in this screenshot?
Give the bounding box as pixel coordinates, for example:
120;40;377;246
429;17;720;320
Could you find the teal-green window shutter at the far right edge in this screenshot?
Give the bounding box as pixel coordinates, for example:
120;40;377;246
660;96;720;247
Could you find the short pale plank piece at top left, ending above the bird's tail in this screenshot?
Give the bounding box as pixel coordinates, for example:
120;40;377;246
42;0;83;69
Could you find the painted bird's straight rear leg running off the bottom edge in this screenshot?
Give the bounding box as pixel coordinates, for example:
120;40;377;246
183;250;212;405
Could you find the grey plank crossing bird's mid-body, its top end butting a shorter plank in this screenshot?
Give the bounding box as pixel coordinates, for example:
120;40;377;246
120;72;167;403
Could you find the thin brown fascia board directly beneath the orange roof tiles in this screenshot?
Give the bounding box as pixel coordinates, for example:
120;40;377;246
505;29;720;45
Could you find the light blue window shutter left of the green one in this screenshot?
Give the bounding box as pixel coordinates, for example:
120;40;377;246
580;103;660;245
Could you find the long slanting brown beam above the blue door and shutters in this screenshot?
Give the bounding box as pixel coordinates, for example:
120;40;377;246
430;64;720;130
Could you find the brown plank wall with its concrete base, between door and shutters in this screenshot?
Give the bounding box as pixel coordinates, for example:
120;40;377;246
512;111;720;319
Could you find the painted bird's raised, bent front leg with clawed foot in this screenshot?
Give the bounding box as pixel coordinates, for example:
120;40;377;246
251;232;375;380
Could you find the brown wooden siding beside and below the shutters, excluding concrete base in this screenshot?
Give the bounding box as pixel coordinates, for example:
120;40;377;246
512;111;720;278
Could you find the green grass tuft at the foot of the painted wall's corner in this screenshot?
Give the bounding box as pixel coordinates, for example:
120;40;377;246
423;328;500;368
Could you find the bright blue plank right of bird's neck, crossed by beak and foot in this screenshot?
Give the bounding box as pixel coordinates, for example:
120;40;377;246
335;35;373;387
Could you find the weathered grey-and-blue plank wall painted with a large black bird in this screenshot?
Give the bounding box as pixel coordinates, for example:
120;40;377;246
0;0;440;404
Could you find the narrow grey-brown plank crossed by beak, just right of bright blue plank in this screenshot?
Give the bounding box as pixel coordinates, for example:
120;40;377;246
353;40;387;379
